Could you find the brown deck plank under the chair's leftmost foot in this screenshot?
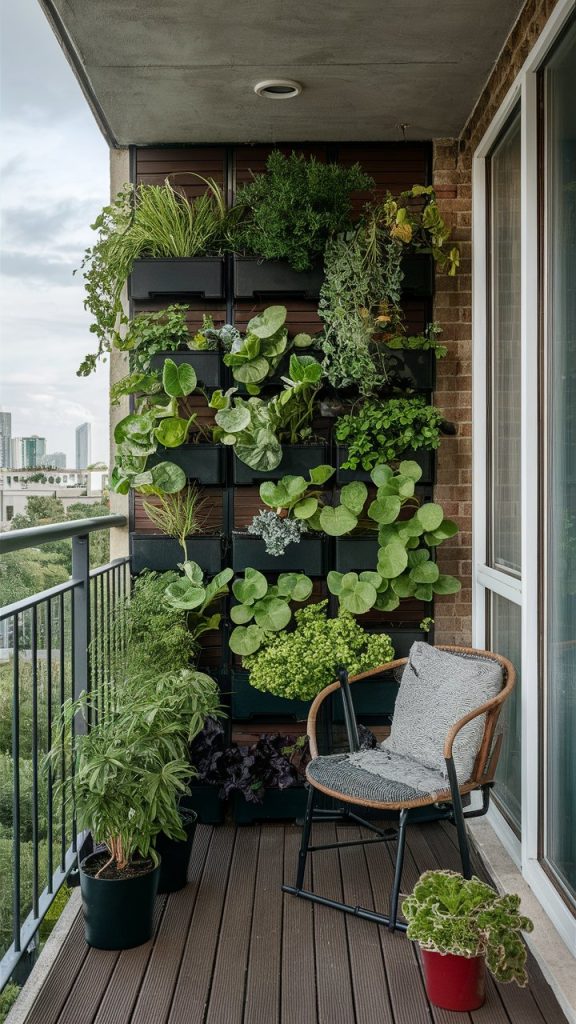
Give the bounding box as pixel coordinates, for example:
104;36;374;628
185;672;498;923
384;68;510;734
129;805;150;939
280;825;318;1024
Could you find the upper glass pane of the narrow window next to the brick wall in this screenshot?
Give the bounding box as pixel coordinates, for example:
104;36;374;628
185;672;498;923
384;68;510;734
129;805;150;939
489;112;521;575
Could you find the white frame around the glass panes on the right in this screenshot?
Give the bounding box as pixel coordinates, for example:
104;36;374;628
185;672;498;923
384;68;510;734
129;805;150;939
472;0;576;955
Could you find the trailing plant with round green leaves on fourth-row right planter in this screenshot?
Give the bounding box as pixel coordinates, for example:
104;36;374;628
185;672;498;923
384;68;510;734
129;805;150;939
327;462;461;615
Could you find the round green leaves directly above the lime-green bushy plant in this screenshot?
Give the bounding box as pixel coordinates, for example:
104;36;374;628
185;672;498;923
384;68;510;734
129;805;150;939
230;568;312;657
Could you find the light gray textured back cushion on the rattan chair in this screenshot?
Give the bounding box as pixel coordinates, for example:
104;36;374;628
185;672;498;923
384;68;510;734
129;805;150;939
381;641;502;782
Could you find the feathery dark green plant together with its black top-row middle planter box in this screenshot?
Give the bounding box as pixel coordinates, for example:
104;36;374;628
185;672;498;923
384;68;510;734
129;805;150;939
230;150;374;299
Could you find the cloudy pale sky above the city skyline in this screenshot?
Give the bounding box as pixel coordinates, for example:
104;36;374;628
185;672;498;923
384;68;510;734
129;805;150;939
0;0;109;467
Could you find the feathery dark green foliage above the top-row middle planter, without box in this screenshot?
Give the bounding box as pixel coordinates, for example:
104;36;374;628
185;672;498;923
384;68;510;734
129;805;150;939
236;150;374;270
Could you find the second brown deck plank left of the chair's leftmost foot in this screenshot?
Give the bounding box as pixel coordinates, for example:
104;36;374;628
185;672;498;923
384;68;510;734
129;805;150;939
206;828;260;1024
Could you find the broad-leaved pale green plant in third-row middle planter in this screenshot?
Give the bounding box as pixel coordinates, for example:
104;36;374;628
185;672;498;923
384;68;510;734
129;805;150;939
210;354;322;472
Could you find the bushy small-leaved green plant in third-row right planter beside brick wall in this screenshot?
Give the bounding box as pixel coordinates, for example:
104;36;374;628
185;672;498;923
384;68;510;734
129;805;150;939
335;395;443;470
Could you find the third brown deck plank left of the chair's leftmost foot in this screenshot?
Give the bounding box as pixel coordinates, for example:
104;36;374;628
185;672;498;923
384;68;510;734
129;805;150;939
168;825;236;1024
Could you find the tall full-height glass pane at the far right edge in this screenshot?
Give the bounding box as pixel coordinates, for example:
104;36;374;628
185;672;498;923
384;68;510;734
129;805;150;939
544;19;576;898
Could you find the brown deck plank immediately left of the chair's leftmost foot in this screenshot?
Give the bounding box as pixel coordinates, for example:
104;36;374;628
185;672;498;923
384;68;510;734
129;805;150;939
243;828;284;1024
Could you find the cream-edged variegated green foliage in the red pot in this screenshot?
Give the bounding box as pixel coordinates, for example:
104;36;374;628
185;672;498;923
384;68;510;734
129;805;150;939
402;870;534;986
